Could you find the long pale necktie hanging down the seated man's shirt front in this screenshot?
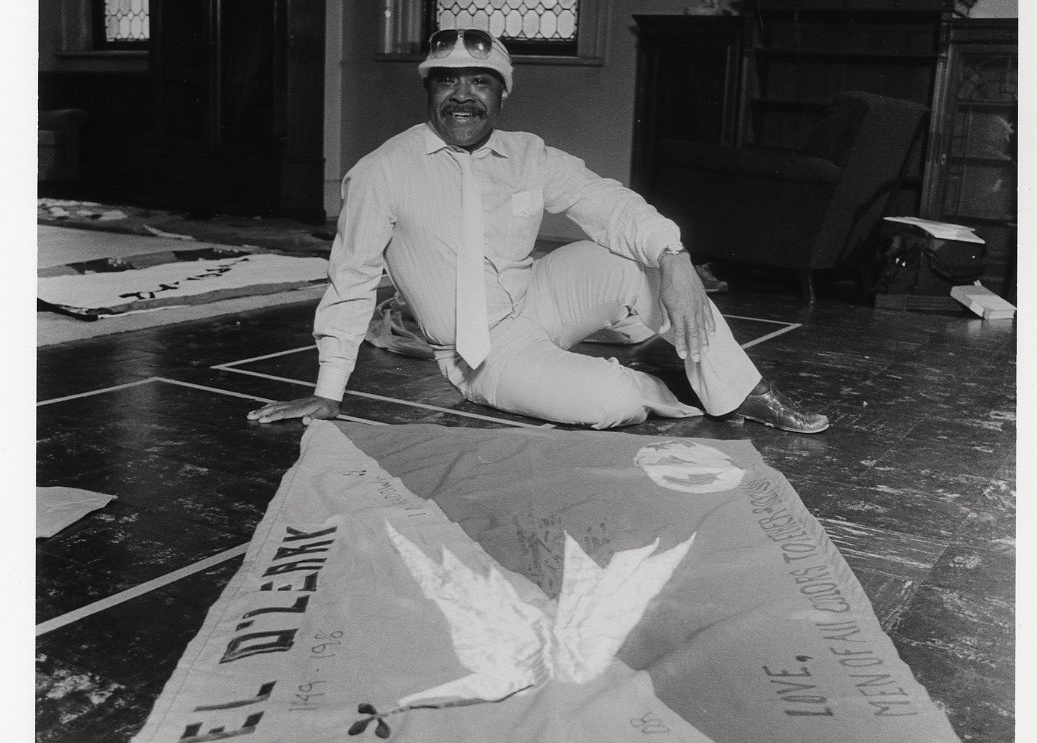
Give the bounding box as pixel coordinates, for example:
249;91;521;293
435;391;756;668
451;150;489;368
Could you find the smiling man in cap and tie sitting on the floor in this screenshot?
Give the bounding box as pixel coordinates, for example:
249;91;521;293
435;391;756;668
249;29;829;434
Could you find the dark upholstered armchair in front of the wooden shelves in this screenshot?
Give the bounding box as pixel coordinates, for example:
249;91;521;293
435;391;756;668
650;92;927;302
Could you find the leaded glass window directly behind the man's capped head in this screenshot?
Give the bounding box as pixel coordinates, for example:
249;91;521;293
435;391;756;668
435;0;580;55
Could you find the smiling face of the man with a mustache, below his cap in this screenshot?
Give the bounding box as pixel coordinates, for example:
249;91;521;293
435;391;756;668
425;67;507;149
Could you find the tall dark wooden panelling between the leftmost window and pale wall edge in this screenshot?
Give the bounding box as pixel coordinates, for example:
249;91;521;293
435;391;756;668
145;0;325;222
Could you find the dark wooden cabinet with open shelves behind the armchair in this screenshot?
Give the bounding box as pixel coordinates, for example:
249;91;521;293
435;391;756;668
632;0;953;214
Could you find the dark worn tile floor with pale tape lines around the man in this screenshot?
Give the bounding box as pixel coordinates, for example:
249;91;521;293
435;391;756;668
36;282;1016;743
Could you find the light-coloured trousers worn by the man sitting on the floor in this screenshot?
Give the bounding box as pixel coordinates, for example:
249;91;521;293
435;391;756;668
438;241;760;429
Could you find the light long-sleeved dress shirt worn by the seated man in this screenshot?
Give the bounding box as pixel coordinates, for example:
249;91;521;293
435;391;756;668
313;123;680;400
